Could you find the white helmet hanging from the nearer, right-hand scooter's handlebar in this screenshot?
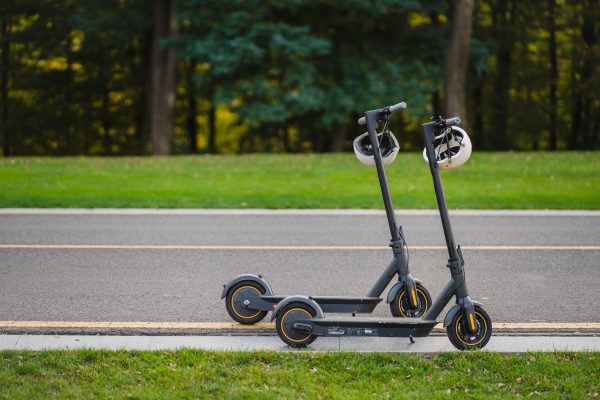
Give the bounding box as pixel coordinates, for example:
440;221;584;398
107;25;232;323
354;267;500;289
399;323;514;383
423;126;472;169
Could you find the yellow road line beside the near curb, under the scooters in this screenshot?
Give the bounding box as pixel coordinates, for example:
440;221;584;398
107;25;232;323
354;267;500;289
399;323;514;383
0;321;600;330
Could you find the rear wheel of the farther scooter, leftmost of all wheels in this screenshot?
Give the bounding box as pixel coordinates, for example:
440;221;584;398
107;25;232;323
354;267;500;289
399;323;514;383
225;281;267;325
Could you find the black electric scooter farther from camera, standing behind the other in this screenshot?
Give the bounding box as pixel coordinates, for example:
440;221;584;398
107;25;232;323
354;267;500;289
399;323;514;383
221;103;431;324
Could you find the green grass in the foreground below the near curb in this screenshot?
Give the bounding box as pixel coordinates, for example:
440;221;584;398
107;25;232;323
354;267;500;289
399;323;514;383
0;350;600;399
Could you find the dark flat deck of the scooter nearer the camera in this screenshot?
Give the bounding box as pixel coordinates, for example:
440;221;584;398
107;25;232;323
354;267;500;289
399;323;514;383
294;317;437;337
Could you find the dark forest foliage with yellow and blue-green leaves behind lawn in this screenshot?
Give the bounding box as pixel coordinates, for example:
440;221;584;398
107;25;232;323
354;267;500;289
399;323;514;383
0;0;600;155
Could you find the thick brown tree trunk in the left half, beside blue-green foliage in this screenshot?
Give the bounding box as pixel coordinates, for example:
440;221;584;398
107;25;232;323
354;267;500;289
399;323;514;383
148;0;177;155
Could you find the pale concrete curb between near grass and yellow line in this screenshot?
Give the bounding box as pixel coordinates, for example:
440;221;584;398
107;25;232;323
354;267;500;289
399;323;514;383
0;335;600;353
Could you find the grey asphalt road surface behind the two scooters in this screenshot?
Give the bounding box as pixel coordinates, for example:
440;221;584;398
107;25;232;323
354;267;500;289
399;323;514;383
0;214;600;322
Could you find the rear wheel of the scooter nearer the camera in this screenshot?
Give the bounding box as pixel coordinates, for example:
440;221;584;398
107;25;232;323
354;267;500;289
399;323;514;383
275;303;317;348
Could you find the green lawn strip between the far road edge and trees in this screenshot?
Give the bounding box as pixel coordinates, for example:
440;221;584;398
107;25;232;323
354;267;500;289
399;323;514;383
0;152;600;209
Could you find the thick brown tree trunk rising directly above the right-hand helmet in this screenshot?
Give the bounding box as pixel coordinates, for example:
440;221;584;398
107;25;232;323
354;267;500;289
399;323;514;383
444;0;473;128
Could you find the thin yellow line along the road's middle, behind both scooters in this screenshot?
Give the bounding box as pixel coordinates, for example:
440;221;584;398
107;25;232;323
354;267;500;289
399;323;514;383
0;244;600;251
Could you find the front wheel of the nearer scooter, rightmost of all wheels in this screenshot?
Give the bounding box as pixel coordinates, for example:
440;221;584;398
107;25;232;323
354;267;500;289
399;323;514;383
446;306;492;350
